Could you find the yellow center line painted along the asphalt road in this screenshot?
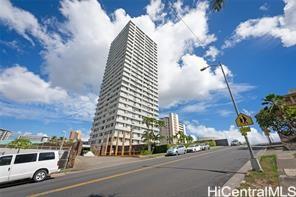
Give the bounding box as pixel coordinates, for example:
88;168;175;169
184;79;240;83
29;149;230;197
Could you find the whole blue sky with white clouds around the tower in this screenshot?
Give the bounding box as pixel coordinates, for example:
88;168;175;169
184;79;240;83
0;0;296;144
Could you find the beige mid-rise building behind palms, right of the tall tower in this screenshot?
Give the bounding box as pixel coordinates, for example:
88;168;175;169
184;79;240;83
160;113;186;144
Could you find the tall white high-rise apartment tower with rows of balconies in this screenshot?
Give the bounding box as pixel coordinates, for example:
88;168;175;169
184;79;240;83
90;21;159;155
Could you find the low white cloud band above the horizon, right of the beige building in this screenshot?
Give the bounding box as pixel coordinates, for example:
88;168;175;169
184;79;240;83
186;121;280;144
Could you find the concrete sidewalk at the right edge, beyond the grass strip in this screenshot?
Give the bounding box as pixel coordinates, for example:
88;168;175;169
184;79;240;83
266;150;296;194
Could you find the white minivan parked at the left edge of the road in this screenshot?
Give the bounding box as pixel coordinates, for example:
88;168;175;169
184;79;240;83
0;151;59;183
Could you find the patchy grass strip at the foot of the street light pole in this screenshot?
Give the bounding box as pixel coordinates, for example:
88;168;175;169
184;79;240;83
240;155;279;189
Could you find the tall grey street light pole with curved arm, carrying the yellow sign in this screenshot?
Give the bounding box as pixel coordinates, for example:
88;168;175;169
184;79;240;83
200;63;263;171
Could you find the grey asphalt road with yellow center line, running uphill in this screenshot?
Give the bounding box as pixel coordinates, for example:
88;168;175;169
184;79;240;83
0;147;256;197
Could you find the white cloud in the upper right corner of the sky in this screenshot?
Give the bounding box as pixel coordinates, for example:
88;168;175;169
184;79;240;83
222;0;296;48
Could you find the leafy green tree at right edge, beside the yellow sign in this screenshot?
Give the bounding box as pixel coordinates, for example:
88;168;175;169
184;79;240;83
255;94;296;136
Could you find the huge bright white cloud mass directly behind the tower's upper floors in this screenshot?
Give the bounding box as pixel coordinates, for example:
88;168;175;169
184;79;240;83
0;0;231;106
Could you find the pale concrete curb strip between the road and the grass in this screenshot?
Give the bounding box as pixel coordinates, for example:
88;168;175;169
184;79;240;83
223;149;266;190
